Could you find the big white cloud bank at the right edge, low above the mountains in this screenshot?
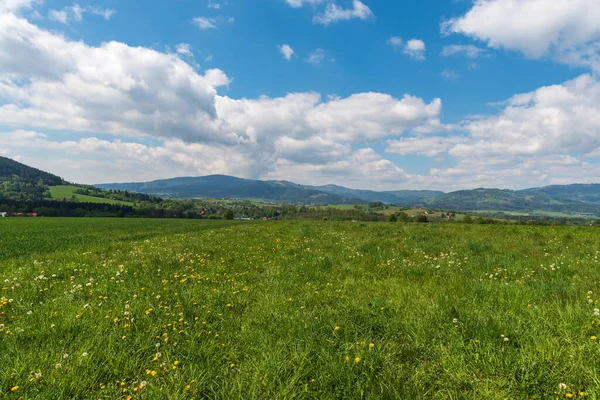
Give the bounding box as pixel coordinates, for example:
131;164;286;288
386;74;600;188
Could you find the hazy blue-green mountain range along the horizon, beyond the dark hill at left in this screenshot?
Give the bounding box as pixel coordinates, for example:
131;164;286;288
96;175;600;217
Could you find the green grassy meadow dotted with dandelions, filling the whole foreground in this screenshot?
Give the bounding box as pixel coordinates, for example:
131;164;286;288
0;218;600;399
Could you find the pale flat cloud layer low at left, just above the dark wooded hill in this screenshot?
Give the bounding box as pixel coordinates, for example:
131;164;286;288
0;130;252;183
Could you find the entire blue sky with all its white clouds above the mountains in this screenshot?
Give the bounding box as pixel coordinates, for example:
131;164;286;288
0;0;600;191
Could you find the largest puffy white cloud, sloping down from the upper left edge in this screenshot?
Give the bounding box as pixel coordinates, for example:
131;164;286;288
0;14;232;141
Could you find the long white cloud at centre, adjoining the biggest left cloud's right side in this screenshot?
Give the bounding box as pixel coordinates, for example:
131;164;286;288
217;93;442;143
